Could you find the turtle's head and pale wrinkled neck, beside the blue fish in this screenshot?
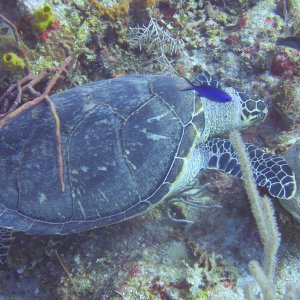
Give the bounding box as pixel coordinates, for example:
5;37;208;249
201;87;268;136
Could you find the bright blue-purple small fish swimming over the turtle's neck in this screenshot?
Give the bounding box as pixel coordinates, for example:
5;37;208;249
181;77;232;103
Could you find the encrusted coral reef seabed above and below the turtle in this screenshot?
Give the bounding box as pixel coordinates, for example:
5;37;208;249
0;0;300;300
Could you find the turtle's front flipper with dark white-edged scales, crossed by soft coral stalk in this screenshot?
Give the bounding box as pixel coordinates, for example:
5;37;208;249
198;138;297;199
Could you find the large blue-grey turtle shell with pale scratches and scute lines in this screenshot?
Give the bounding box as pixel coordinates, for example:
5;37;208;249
0;75;204;234
